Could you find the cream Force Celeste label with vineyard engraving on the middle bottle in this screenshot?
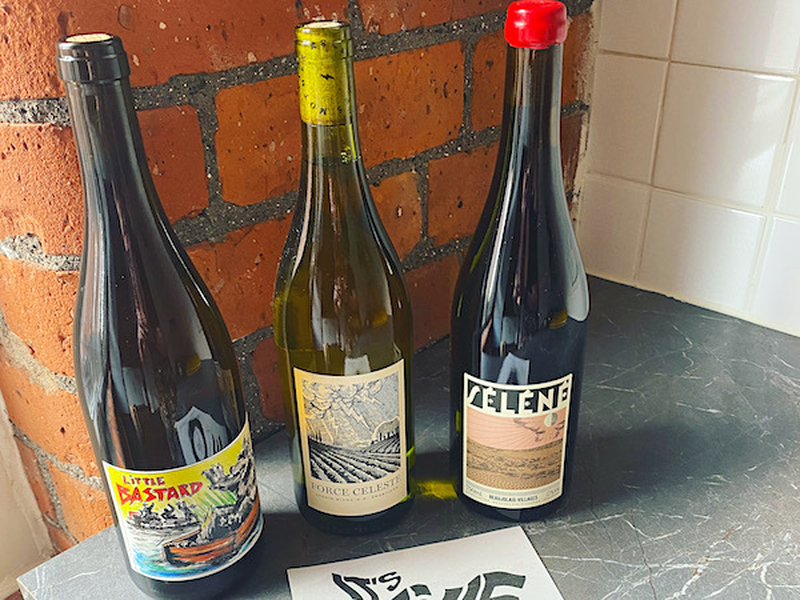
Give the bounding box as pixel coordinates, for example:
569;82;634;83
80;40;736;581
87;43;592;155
294;360;408;517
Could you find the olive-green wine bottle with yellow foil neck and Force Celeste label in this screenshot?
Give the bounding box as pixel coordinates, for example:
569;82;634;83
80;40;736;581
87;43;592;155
274;21;414;534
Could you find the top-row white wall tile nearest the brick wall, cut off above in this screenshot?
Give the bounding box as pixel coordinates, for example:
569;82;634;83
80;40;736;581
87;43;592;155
598;0;677;58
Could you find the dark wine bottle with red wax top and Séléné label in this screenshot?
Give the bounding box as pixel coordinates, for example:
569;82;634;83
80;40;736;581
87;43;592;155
450;0;589;521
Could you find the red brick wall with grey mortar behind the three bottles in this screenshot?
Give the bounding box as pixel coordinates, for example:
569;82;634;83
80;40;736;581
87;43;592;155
0;0;592;550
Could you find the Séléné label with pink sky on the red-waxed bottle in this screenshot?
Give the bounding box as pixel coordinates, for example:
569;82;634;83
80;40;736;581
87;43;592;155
462;373;572;509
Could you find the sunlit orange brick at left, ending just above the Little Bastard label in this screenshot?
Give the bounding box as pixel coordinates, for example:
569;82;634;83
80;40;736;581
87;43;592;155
0;349;99;475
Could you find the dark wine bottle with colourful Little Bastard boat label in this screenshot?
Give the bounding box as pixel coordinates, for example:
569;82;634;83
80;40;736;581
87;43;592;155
58;33;262;597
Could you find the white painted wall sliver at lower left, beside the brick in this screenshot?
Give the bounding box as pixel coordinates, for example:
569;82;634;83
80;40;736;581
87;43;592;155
0;396;53;598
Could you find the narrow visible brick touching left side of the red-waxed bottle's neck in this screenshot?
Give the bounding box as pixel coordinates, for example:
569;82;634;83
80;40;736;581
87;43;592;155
472;30;508;131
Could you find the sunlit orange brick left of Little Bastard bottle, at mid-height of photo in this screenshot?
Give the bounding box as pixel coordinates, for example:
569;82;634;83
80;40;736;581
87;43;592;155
0;256;78;375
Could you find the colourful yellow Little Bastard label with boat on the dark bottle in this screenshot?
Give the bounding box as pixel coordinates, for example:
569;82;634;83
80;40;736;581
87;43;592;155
103;421;262;581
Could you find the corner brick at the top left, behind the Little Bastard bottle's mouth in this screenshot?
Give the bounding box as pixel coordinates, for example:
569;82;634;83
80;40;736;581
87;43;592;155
0;0;346;98
